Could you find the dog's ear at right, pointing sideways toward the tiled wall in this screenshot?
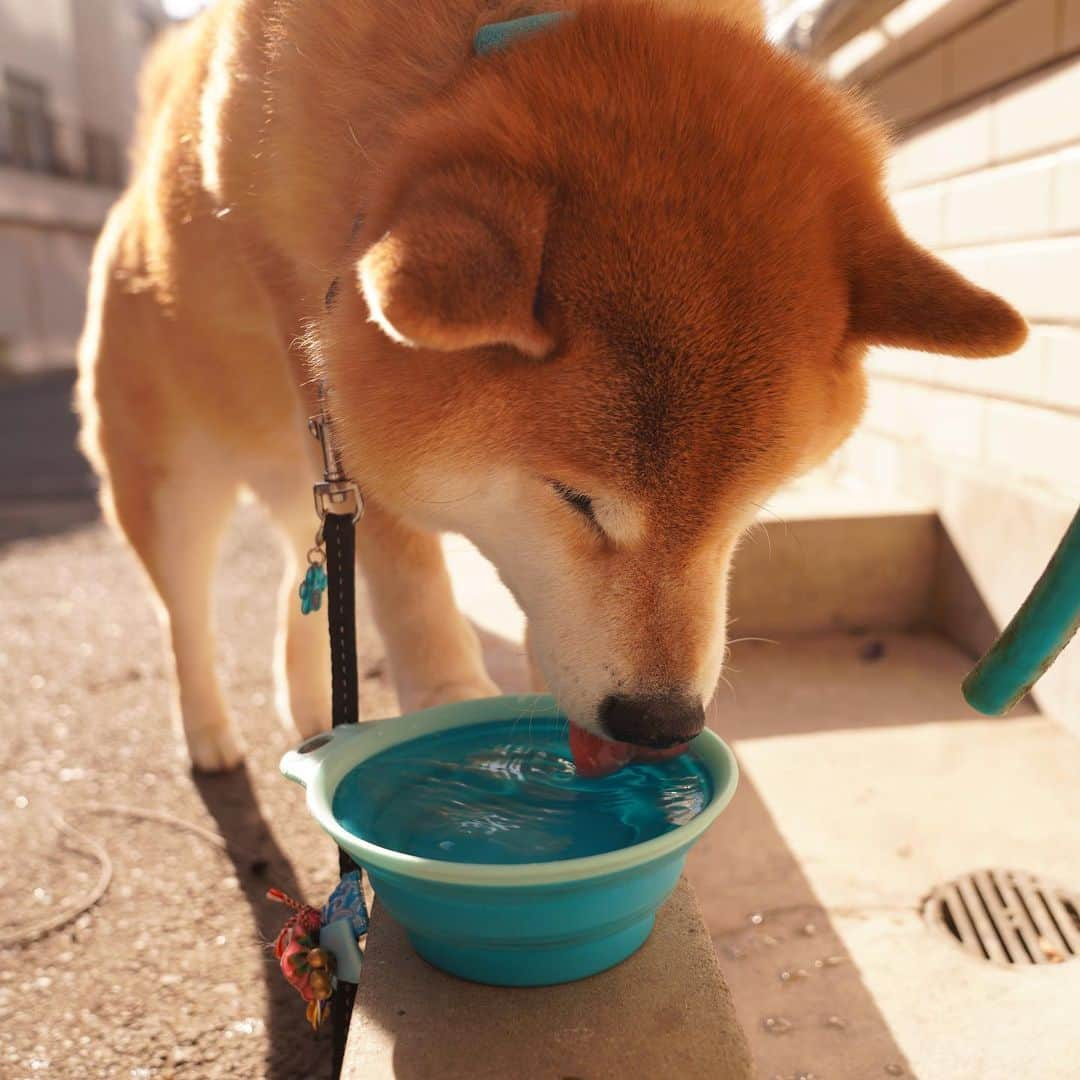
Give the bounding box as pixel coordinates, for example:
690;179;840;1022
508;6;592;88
848;204;1027;356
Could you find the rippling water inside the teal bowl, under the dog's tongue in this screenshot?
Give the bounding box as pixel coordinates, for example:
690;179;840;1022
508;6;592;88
334;718;712;864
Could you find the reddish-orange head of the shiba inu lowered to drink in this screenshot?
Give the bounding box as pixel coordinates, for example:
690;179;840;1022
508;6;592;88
320;5;1025;746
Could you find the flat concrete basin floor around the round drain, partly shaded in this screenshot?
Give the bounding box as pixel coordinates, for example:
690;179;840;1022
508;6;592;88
688;633;1080;1080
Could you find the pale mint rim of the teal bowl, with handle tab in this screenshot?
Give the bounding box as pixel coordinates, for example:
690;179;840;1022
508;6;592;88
281;694;739;888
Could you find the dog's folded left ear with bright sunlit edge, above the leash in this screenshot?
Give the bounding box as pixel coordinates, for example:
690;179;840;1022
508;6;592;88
357;166;553;356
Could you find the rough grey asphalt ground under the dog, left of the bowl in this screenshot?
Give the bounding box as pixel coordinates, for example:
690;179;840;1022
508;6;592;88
0;377;393;1080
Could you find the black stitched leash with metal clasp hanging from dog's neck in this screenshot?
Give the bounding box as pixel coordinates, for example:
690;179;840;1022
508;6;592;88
308;399;364;1078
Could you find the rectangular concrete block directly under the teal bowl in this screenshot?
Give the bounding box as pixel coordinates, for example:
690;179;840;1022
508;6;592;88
341;881;755;1080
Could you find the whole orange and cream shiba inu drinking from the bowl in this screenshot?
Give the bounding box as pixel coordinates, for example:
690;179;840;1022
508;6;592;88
79;0;1026;769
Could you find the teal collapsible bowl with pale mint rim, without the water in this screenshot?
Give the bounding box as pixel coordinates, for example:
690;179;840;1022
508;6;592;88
281;696;738;986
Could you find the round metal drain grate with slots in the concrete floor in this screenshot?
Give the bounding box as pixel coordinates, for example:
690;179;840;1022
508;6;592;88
922;870;1080;964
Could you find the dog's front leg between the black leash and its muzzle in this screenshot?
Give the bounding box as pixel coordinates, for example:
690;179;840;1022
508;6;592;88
356;502;499;712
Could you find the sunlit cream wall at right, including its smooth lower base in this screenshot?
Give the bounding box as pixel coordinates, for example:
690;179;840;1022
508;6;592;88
824;0;1080;730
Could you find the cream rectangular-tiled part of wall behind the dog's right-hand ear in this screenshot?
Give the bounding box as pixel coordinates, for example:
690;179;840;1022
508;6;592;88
842;0;1080;500
